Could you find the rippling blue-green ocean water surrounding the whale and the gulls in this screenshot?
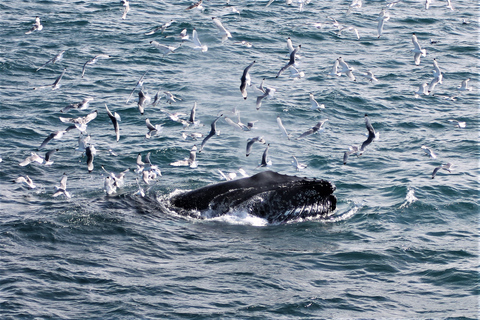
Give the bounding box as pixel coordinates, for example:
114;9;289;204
0;0;480;319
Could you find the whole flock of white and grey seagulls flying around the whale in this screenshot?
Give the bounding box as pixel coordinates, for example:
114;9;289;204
10;0;472;198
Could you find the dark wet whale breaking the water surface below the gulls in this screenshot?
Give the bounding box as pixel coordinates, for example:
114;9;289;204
170;171;337;224
